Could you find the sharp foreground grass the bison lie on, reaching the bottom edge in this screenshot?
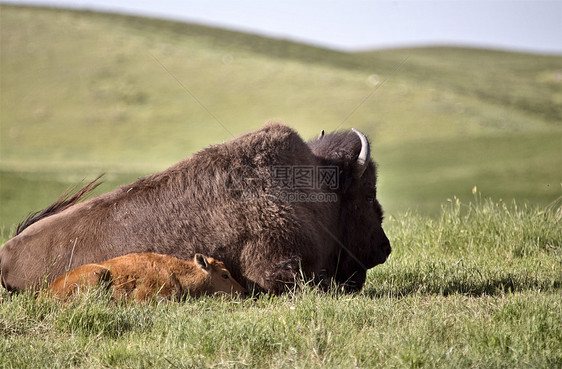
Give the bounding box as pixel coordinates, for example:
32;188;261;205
0;197;562;368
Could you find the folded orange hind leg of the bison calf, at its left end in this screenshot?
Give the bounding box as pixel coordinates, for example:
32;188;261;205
48;264;111;299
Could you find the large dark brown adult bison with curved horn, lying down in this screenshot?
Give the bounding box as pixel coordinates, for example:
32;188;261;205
0;123;391;293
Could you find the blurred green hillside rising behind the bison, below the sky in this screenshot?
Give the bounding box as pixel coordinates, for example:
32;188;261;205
0;6;562;231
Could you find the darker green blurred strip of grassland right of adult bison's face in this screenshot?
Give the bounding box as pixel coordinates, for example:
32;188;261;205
379;133;562;215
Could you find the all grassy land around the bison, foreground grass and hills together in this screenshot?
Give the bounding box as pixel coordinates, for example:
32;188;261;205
0;6;562;368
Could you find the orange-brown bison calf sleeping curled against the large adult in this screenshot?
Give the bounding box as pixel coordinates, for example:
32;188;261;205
47;253;244;301
